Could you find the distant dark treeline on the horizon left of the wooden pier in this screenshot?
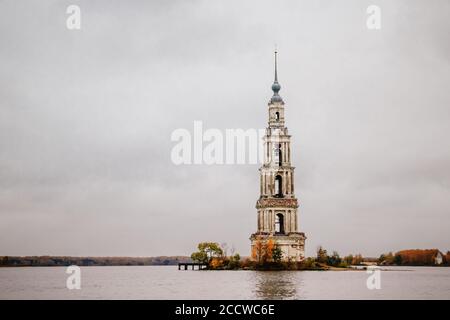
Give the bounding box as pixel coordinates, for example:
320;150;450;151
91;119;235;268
0;256;191;267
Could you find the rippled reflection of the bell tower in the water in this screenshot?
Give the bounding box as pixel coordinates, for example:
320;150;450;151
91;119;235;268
253;271;301;299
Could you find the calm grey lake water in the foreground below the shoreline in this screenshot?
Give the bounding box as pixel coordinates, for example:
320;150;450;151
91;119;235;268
0;266;450;299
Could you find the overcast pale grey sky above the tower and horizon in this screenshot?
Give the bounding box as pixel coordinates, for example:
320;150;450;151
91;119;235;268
0;0;450;256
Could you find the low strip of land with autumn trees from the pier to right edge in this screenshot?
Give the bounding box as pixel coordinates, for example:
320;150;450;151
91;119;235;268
191;239;450;271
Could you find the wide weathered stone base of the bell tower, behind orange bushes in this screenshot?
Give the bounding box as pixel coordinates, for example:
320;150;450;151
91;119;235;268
250;232;306;262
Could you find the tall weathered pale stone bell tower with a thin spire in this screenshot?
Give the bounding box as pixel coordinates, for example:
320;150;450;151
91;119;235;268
250;51;306;261
